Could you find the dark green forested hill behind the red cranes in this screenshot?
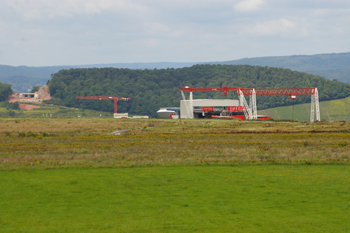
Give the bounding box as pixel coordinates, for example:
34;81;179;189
49;65;350;117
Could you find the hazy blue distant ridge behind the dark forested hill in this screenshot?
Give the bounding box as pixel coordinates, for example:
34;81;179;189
0;53;350;92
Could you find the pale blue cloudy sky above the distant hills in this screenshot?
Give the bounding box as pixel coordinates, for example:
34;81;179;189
0;0;350;66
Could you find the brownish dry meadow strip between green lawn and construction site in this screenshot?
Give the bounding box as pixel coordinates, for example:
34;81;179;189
0;118;350;170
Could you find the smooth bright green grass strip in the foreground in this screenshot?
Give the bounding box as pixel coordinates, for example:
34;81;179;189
0;165;350;232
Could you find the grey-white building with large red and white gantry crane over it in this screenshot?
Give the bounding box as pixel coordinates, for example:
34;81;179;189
157;86;320;122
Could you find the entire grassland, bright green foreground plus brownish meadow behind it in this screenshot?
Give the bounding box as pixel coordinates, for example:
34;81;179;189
0;118;350;232
